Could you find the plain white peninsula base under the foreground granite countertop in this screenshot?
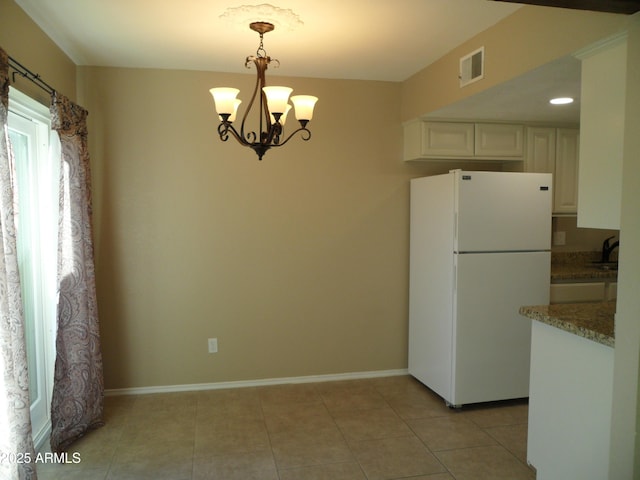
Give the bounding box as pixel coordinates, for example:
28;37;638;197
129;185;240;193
527;321;614;480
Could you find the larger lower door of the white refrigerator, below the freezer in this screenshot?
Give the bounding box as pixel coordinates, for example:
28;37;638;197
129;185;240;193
445;252;551;405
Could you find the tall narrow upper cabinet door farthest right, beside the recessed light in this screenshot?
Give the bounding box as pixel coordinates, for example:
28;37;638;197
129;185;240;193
553;128;580;213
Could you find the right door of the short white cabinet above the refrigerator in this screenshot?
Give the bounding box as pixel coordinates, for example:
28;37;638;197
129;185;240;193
475;123;524;158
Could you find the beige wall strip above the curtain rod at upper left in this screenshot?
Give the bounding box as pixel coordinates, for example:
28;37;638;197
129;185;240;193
0;0;76;106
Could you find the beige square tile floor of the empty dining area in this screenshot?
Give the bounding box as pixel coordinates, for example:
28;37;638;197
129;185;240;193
38;376;535;480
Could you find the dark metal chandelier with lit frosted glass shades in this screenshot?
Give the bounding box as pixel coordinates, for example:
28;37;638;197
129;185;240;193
209;22;318;160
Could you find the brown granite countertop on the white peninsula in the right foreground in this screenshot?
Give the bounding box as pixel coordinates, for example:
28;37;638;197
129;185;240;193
520;301;616;347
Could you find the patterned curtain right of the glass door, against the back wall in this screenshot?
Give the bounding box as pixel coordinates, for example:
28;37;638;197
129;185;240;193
51;93;104;452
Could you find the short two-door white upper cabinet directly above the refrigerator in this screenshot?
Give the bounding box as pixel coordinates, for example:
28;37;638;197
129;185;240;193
404;120;524;161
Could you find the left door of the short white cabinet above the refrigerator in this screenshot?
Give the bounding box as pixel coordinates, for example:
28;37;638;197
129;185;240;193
422;122;473;157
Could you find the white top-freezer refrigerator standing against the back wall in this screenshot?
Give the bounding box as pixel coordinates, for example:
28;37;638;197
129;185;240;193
409;170;553;407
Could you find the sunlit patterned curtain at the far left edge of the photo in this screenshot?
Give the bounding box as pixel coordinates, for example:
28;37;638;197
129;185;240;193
0;48;37;480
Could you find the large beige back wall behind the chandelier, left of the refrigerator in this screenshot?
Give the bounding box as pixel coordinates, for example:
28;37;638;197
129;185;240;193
79;68;452;388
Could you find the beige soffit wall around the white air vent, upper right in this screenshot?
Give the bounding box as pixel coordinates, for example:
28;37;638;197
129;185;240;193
401;6;628;121
